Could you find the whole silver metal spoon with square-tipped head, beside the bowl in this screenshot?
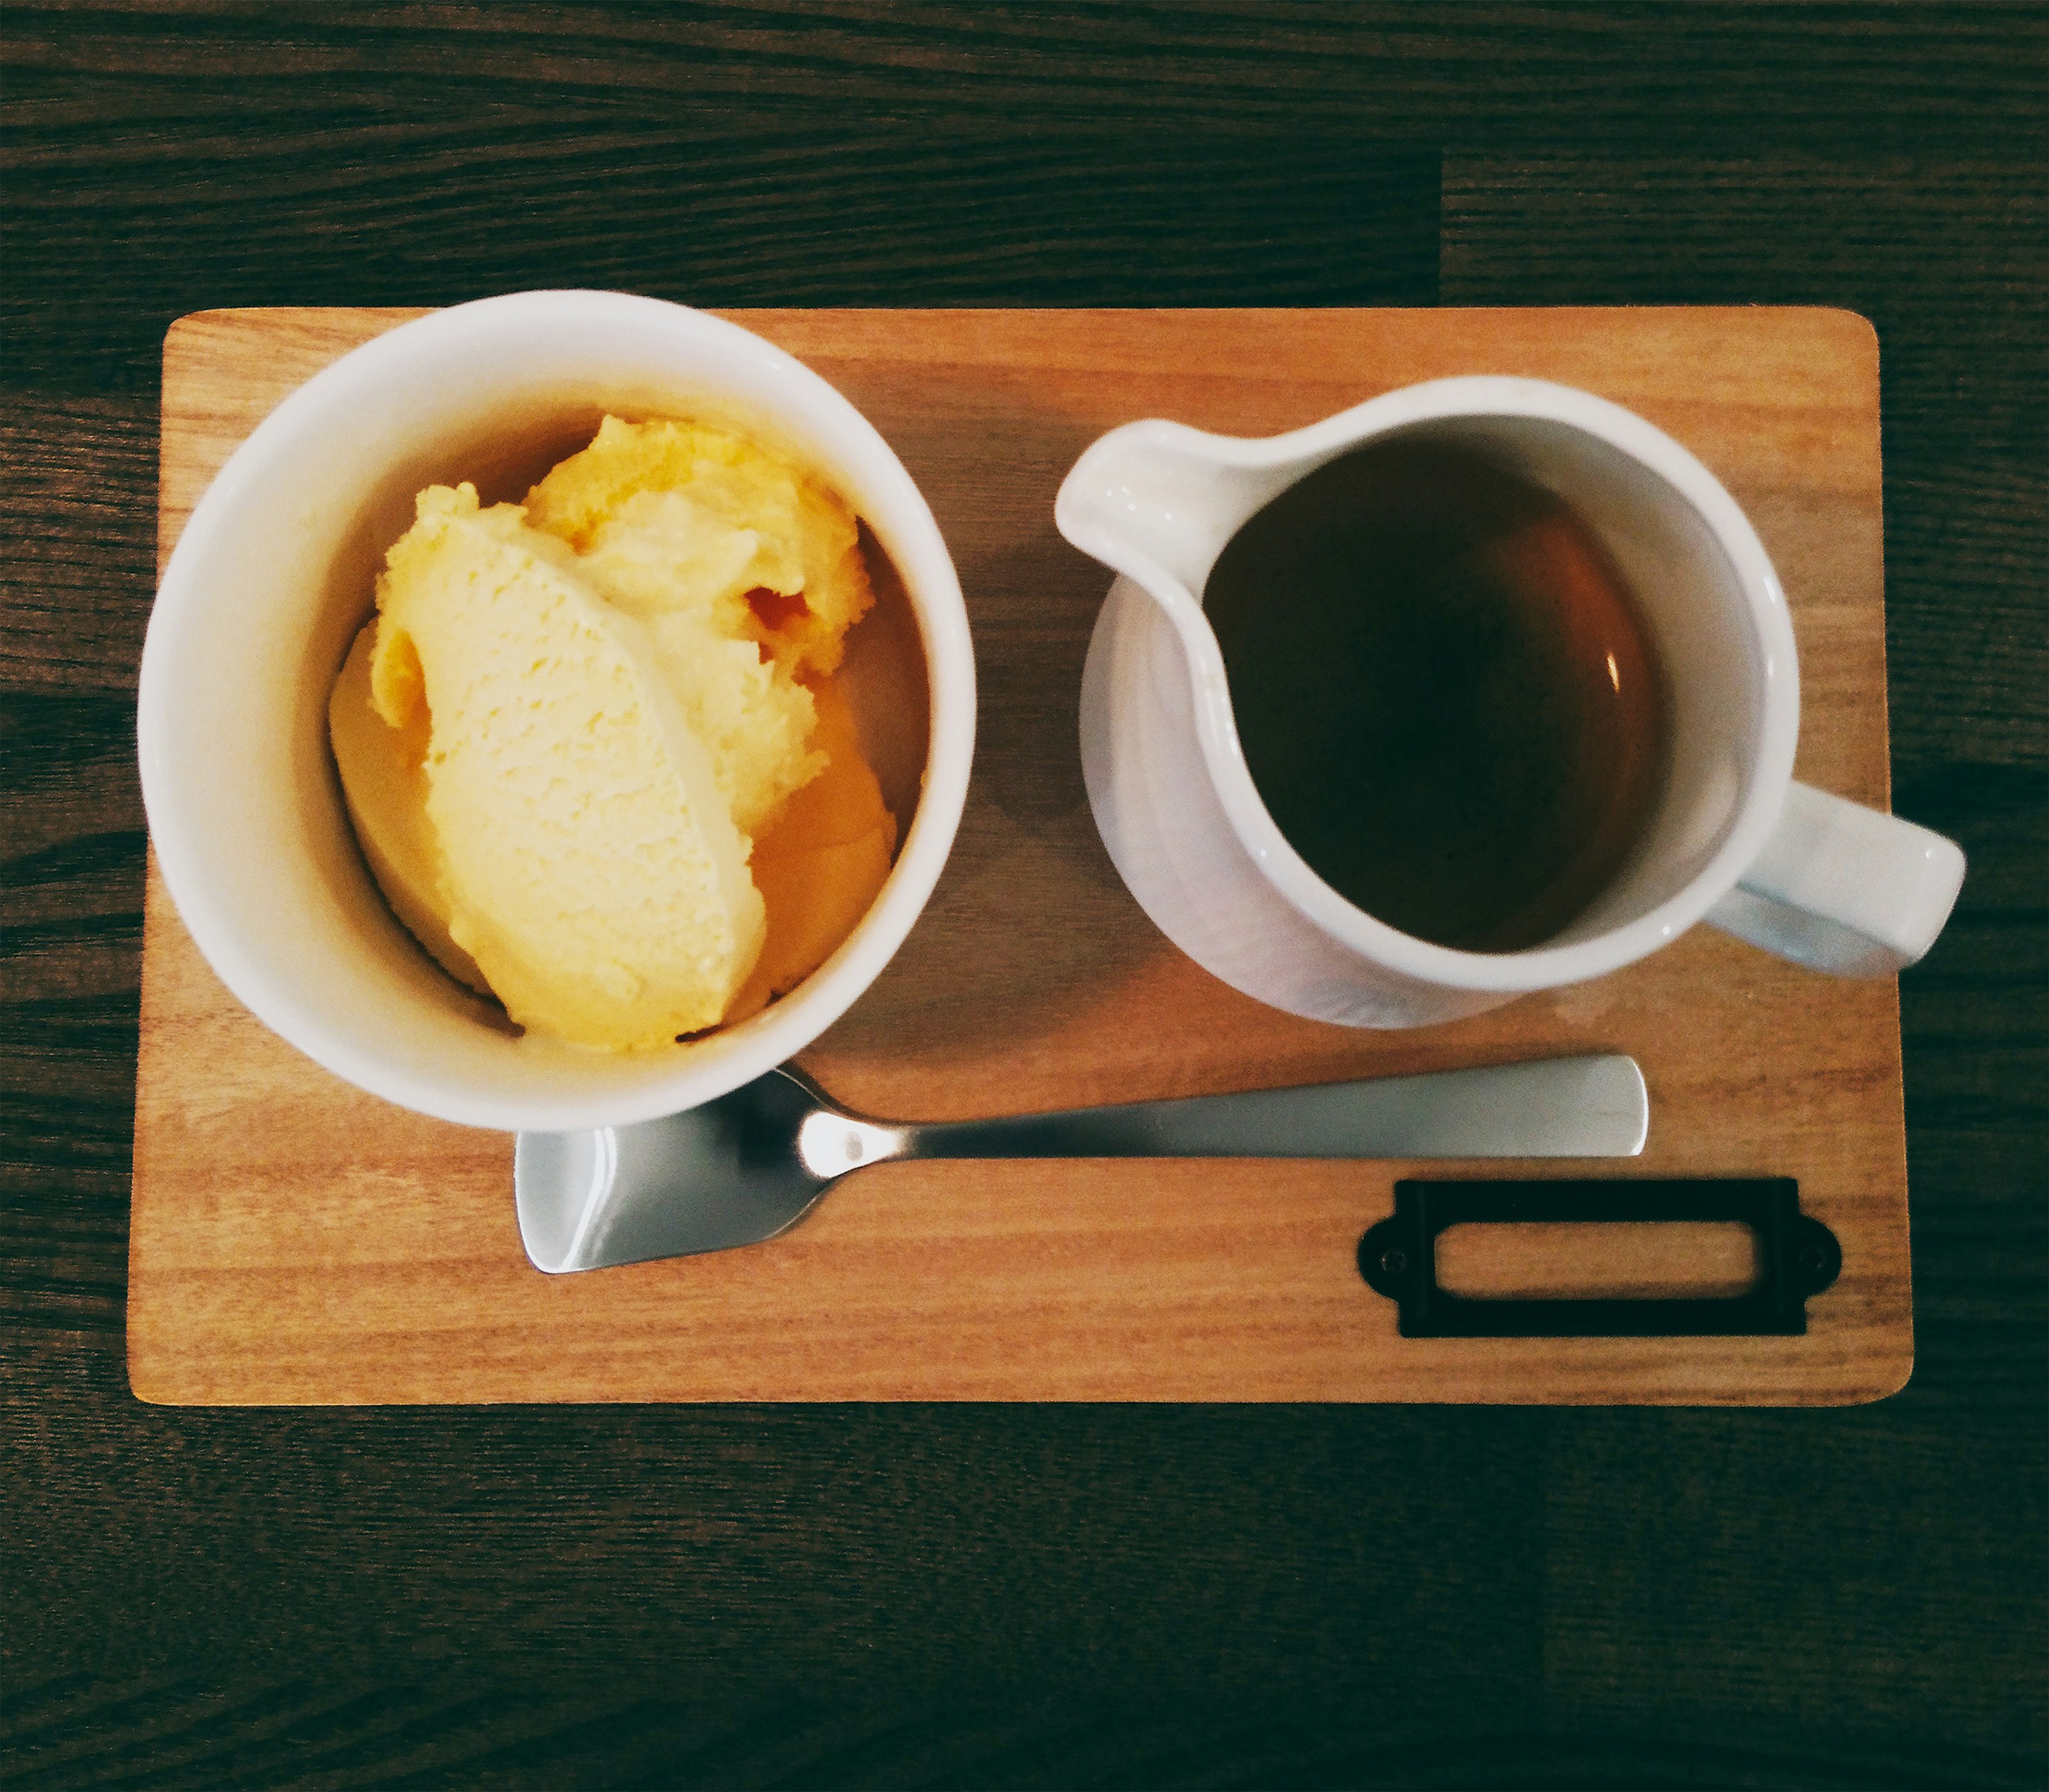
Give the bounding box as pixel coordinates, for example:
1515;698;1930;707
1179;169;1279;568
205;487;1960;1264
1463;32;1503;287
512;1057;1649;1274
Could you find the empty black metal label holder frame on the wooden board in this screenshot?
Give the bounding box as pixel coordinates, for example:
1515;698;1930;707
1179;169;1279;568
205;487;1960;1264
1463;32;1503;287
1359;1176;1842;1337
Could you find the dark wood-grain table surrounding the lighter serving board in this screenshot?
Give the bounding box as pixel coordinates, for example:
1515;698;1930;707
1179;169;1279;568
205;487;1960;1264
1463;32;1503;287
0;0;2049;1788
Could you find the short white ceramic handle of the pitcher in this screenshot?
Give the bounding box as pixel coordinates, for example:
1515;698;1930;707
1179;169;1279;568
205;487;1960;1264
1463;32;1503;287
1707;784;1963;977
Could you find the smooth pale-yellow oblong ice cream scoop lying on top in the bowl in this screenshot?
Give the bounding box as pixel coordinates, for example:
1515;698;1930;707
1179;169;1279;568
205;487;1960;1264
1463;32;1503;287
371;485;766;1048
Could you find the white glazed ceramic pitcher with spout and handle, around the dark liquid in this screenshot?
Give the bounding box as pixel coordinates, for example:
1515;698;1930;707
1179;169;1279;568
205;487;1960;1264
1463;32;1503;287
1055;377;1963;1026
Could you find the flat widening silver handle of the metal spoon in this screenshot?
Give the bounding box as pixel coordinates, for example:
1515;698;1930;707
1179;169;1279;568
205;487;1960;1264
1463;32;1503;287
895;1057;1649;1157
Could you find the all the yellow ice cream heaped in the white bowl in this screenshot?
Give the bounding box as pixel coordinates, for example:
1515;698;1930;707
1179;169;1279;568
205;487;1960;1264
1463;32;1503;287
330;418;895;1050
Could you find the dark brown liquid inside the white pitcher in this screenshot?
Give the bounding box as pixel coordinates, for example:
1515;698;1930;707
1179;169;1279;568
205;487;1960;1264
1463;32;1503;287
1203;439;1666;952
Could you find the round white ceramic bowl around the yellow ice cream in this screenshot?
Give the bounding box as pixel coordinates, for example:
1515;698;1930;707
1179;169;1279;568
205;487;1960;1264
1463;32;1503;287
137;293;975;1130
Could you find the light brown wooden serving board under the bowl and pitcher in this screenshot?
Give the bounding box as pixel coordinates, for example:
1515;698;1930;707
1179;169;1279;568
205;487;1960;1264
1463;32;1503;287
129;309;1914;1403
